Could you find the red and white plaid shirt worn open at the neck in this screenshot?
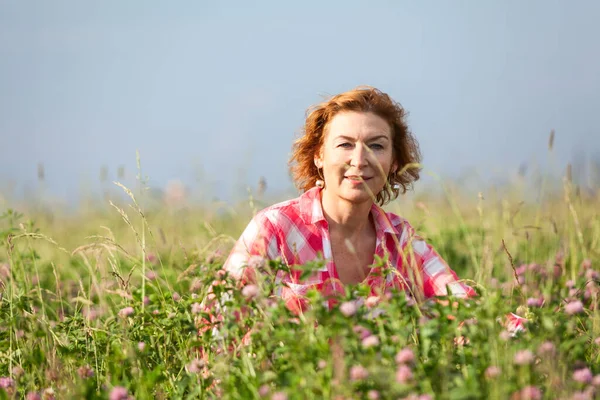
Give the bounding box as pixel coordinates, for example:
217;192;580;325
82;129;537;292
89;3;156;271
224;187;476;311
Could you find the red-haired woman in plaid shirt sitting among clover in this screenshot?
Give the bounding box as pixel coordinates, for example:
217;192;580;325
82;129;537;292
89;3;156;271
224;87;475;312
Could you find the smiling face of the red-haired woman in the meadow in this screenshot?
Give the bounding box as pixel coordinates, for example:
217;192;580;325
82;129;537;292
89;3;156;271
315;111;397;203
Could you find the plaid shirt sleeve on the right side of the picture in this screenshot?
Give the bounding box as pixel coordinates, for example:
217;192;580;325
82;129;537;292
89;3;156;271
404;222;477;298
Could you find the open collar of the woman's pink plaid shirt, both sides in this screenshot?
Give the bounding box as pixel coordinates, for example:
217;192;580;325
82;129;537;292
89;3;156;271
300;186;401;235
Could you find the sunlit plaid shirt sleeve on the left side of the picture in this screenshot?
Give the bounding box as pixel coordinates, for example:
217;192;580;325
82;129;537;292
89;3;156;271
223;210;279;282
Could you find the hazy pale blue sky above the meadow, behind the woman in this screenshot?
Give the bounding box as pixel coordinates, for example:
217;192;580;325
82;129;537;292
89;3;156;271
0;0;600;203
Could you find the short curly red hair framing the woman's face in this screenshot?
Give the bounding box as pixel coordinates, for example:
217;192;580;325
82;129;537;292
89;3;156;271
289;86;421;205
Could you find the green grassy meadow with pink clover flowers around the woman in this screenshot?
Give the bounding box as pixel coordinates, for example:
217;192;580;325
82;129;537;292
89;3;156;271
0;162;600;400
